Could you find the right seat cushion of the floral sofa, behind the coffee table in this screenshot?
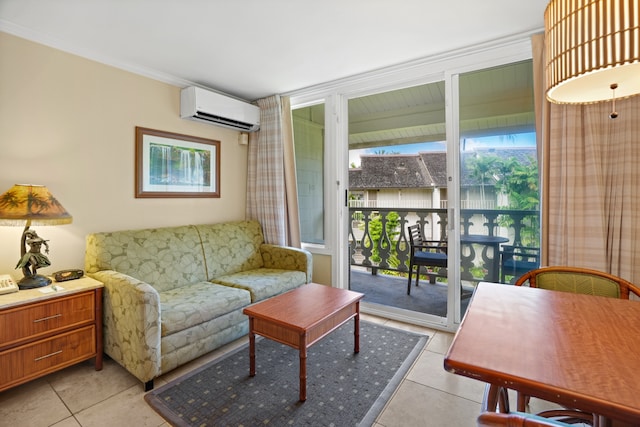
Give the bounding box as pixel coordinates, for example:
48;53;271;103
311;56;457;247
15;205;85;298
214;268;307;302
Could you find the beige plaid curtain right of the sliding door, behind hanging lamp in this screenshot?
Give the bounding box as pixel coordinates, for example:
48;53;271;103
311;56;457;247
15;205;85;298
532;35;640;283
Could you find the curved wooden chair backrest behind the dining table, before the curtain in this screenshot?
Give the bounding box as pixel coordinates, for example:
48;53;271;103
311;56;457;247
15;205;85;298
514;266;640;299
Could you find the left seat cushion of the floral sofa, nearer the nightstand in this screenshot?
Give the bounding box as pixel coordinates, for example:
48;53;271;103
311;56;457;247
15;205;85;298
160;282;251;337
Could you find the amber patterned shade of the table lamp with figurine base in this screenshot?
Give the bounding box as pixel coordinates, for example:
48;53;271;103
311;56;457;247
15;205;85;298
0;184;73;226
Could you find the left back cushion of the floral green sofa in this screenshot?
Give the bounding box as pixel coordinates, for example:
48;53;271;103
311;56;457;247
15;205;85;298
85;225;207;292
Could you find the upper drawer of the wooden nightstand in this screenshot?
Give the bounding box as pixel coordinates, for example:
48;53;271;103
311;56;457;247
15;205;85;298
0;291;96;348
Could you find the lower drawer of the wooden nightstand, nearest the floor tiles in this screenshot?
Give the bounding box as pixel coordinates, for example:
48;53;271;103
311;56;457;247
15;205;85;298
0;325;96;390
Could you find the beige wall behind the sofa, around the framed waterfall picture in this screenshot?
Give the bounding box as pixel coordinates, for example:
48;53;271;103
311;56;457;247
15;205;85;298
0;32;247;279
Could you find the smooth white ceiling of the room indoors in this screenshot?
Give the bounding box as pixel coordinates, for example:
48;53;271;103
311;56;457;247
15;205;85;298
0;0;548;101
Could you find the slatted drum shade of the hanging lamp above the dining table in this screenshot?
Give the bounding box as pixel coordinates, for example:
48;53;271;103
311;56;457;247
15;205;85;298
544;0;640;104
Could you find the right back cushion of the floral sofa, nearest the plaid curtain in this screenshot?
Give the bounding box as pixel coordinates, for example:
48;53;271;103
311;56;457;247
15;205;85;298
196;221;264;280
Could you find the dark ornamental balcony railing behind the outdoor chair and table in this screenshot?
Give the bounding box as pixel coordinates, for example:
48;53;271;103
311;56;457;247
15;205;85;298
349;207;539;282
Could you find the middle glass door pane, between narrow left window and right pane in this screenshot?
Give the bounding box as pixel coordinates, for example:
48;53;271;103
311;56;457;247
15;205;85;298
347;81;448;319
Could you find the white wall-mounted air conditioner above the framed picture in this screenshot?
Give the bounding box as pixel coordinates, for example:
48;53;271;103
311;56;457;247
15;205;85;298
180;86;260;132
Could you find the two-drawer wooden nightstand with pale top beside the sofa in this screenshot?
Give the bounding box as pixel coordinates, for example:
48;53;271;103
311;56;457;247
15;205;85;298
0;277;103;391
